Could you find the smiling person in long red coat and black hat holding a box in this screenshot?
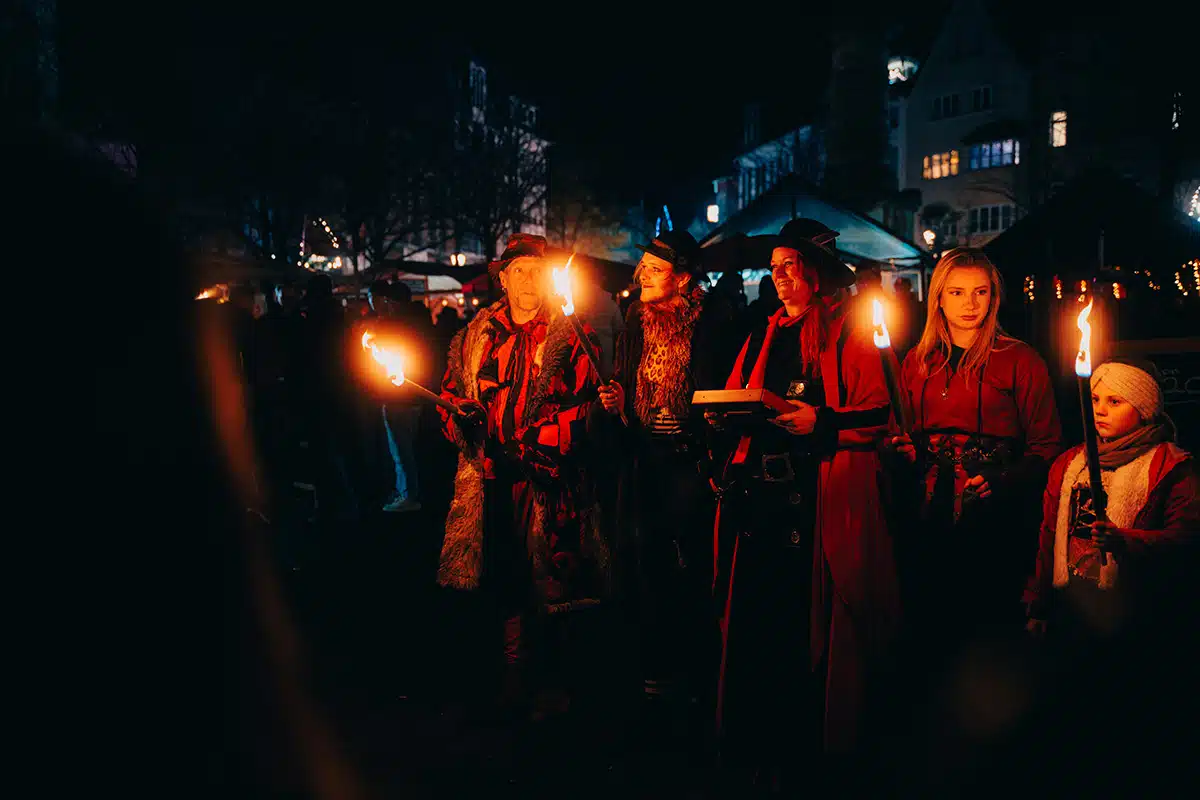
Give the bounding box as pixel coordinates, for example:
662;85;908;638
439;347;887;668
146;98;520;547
714;219;899;781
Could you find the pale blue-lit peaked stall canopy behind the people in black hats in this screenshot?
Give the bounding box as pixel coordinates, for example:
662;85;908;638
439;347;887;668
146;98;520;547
700;175;923;266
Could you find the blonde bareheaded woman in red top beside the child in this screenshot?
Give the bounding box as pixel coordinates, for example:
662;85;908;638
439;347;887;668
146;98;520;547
893;247;1062;655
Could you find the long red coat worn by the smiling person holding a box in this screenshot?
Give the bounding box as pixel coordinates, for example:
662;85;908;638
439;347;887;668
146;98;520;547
715;309;900;752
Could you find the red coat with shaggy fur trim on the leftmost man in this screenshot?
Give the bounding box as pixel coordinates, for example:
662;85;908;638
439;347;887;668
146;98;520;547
438;300;608;610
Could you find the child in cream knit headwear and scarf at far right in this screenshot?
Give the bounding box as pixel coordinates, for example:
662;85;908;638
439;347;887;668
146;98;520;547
1025;361;1200;633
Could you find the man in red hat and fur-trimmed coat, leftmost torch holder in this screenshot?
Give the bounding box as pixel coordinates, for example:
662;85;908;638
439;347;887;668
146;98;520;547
438;234;607;719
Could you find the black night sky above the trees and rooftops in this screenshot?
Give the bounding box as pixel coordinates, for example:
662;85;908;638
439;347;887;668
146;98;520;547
59;0;946;212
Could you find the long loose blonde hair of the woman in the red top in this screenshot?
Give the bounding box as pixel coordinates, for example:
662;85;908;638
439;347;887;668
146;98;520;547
913;247;1012;378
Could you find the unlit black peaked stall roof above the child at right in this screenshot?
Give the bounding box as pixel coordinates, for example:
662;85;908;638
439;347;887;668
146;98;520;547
986;169;1200;285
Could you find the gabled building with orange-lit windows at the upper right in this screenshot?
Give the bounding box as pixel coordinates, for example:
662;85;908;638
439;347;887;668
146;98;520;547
900;0;1198;256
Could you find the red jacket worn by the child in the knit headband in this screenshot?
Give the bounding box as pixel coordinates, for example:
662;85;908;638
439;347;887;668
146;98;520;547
1025;444;1200;615
